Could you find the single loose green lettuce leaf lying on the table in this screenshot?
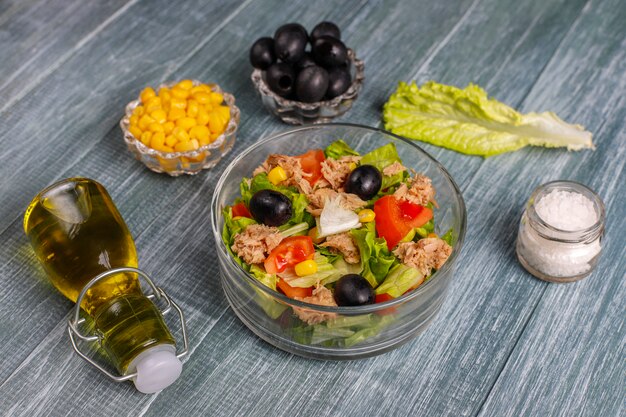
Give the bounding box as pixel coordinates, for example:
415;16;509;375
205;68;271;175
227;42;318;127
383;81;594;157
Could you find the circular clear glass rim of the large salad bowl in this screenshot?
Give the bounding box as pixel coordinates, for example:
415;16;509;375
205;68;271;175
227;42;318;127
211;123;467;315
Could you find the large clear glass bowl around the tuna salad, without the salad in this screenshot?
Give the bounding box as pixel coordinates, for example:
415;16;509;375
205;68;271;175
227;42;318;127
211;124;466;359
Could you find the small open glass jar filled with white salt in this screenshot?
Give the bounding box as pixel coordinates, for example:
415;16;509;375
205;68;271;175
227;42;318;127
516;181;605;283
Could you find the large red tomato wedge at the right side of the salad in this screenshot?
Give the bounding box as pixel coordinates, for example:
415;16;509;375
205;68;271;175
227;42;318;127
374;195;433;250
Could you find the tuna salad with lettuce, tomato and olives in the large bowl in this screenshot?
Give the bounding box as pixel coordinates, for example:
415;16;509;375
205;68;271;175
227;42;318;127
222;140;453;325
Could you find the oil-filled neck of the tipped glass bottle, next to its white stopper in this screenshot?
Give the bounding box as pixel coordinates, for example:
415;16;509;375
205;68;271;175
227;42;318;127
92;292;176;374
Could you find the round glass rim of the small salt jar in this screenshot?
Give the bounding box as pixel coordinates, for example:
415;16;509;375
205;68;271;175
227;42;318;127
526;180;606;243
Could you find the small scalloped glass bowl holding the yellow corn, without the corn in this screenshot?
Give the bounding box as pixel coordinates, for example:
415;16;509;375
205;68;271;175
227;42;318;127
120;80;239;177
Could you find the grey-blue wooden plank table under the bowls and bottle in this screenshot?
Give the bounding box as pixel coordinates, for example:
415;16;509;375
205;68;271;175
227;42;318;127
0;0;626;417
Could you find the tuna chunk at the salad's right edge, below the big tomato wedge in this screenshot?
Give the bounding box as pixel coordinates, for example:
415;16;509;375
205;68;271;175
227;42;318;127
393;237;452;275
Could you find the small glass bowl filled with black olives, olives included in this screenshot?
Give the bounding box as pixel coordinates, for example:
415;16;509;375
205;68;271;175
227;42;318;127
250;22;365;125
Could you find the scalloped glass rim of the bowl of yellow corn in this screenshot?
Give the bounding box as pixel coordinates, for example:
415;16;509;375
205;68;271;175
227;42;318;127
119;79;240;159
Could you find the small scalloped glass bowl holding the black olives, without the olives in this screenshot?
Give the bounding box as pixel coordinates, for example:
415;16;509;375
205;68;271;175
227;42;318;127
252;49;365;125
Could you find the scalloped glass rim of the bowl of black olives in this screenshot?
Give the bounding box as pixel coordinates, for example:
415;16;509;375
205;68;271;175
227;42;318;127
250;48;365;111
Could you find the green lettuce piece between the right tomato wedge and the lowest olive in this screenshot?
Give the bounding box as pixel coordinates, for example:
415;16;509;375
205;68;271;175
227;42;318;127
350;222;397;288
